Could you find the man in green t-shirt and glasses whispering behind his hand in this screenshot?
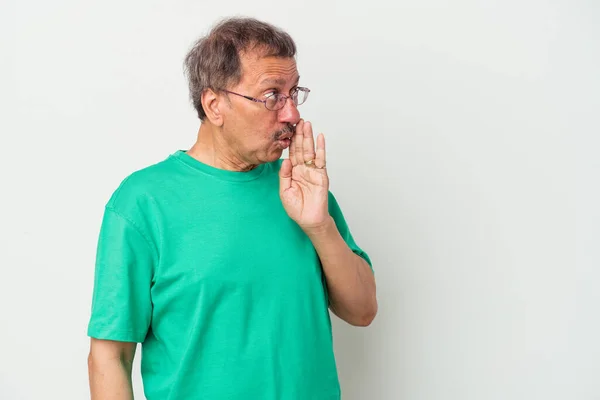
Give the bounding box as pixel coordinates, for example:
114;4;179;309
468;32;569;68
88;19;377;400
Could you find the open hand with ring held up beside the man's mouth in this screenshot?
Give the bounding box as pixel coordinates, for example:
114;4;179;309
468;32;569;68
279;120;330;232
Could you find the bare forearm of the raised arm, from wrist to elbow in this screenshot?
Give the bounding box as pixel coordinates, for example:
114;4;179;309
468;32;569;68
307;218;377;326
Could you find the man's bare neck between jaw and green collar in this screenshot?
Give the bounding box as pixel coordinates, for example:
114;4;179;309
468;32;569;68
187;124;257;171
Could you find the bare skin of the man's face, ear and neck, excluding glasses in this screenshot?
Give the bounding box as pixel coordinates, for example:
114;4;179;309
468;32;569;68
188;53;300;171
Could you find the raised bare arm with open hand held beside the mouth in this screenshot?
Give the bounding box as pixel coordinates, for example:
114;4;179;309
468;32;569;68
279;120;377;326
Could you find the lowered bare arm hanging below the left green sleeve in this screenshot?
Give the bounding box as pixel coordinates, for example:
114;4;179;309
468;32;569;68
88;338;137;400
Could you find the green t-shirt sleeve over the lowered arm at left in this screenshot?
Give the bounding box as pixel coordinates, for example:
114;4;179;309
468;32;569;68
88;206;155;343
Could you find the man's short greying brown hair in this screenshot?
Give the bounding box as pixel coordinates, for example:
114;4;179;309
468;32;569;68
184;18;296;121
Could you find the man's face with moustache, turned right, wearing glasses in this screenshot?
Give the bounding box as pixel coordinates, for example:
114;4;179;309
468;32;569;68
222;53;300;164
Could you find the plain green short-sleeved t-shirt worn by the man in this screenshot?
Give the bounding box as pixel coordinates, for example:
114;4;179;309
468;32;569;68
88;150;371;400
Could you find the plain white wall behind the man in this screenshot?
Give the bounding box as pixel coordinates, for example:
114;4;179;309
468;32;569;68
0;0;600;400
